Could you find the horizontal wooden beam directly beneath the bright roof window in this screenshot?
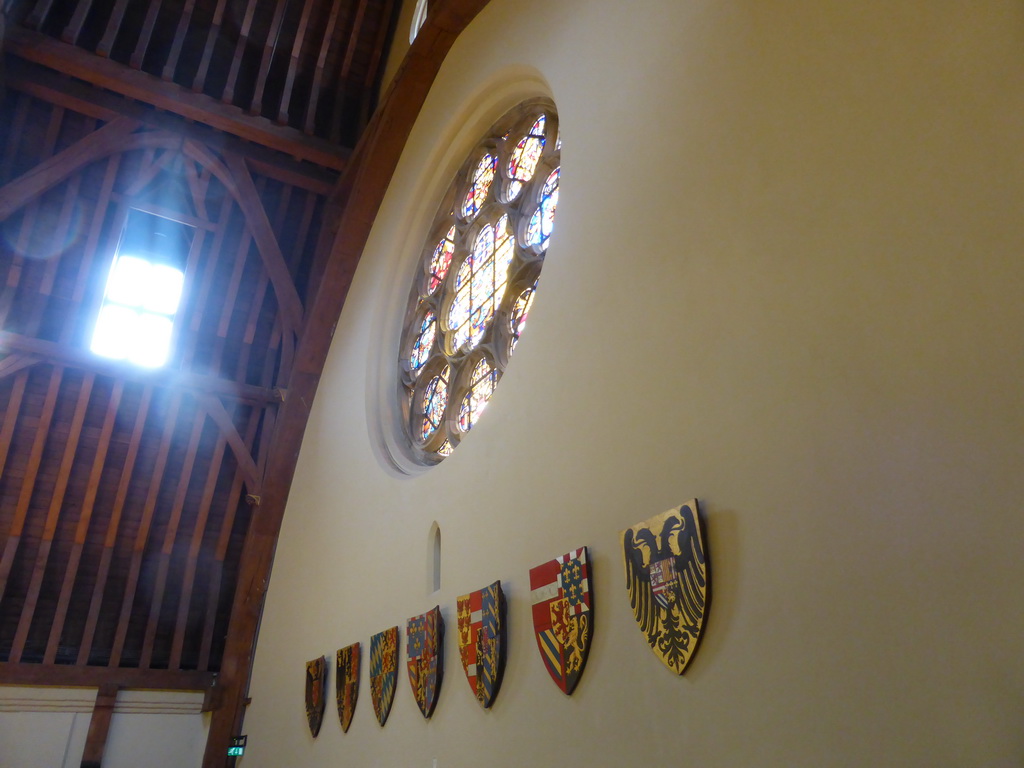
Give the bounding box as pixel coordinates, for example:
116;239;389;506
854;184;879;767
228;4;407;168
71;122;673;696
0;331;282;407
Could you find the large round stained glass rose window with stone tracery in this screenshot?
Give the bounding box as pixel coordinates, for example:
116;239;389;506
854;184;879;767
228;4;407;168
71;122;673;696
399;100;561;464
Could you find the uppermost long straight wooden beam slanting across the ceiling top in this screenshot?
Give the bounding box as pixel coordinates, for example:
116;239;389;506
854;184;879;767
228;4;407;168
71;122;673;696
4;27;349;171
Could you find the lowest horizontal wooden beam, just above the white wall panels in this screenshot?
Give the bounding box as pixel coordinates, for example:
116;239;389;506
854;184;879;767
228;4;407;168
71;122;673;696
0;662;211;692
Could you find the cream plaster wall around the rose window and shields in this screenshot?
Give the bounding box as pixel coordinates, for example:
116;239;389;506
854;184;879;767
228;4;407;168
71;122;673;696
242;0;1024;768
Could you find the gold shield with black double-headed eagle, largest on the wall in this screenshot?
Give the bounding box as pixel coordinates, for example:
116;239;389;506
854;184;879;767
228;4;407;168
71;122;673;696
623;499;709;675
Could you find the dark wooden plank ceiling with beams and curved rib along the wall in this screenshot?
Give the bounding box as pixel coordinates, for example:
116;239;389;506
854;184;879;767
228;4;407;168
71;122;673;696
0;0;495;766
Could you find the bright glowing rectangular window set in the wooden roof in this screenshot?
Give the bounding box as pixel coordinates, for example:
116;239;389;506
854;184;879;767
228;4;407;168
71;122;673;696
89;210;193;368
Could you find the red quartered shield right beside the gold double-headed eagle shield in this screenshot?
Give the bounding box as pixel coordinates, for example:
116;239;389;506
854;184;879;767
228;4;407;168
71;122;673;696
529;547;593;694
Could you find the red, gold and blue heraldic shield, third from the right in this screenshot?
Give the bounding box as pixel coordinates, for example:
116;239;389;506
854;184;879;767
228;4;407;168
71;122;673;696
458;582;506;709
